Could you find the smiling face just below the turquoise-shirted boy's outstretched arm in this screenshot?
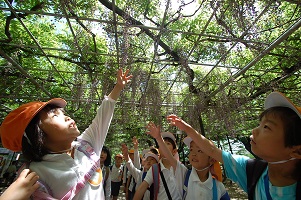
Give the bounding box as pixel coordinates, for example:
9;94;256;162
189;141;210;170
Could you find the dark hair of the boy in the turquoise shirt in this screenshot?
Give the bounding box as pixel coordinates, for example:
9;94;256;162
260;107;301;180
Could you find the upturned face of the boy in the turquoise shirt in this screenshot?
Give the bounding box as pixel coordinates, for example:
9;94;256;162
250;114;291;162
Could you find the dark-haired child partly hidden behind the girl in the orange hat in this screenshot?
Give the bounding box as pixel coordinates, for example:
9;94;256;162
99;146;111;200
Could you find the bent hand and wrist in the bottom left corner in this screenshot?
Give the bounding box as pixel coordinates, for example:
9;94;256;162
0;169;40;200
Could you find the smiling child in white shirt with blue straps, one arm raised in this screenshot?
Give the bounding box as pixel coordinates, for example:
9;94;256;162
146;122;230;200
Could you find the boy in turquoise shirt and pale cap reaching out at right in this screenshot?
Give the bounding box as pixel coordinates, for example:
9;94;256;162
167;92;301;199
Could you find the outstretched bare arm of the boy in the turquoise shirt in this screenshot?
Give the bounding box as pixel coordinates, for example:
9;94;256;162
167;115;223;163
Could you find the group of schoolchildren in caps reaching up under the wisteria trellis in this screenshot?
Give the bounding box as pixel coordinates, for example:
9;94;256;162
0;66;301;200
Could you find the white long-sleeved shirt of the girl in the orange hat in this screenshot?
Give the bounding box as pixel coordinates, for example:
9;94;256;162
29;97;116;200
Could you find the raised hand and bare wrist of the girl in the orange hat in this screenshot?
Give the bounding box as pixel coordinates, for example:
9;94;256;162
108;69;133;101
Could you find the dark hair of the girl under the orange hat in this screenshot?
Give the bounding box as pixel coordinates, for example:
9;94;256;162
22;104;62;162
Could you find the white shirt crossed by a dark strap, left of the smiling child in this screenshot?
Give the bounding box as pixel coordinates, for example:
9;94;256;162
144;161;182;200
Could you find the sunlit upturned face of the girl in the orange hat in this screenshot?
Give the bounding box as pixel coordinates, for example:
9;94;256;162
39;109;80;151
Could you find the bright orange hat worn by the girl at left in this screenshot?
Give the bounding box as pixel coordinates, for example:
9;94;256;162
0;98;67;152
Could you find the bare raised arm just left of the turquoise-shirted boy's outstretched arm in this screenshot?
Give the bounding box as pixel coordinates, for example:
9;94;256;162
146;122;178;169
